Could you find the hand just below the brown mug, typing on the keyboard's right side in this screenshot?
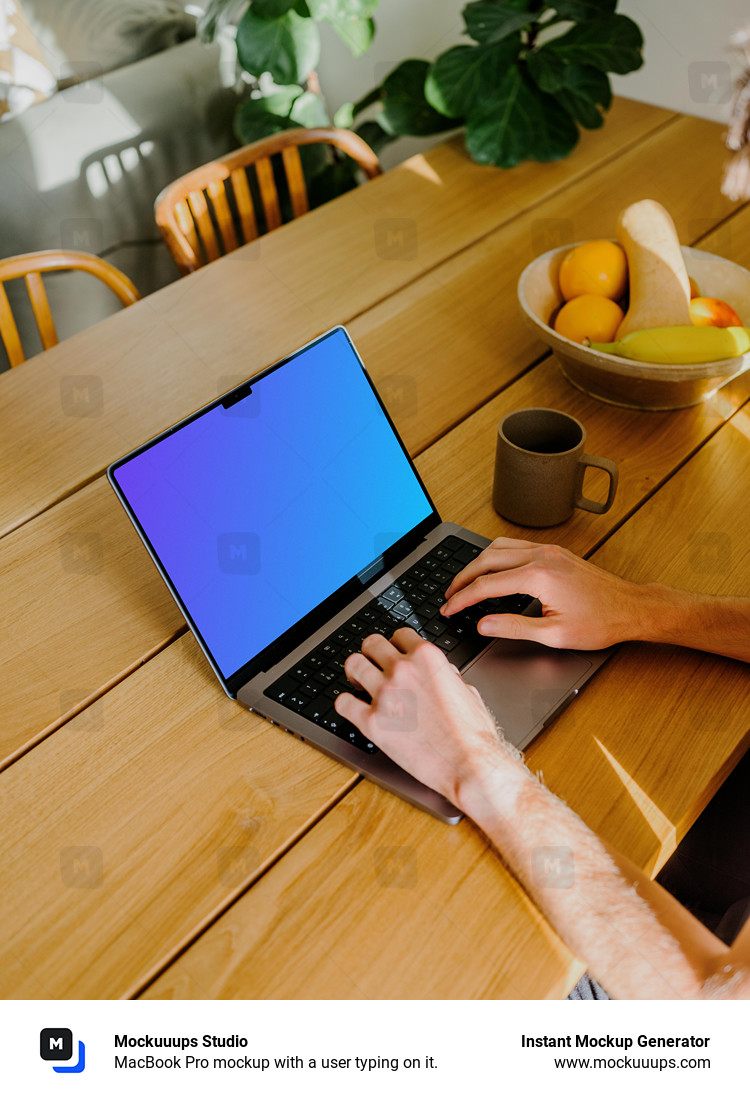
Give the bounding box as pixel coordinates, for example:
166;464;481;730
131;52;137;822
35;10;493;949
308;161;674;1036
441;539;647;649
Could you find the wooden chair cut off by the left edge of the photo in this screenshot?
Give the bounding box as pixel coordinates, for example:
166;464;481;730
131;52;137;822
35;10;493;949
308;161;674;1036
0;249;141;366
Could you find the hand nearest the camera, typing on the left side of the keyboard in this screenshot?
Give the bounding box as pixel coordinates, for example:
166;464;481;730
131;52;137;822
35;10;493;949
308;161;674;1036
335;627;516;806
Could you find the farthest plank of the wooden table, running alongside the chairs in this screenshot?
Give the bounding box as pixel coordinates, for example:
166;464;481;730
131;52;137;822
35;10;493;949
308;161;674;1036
0;100;677;532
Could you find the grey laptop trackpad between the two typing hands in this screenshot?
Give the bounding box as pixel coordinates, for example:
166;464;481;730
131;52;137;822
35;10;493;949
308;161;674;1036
464;638;592;748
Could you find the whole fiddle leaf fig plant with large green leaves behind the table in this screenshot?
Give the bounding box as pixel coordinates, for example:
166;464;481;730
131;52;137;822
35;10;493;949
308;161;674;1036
195;0;643;193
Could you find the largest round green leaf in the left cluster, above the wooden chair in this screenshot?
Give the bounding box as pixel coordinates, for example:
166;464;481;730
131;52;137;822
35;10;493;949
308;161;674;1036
236;9;320;84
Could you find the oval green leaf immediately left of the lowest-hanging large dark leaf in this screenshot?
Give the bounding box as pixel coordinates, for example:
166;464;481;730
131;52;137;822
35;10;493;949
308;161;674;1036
424;34;521;117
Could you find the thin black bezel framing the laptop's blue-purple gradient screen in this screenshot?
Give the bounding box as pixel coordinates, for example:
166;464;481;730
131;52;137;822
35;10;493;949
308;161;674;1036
107;325;440;697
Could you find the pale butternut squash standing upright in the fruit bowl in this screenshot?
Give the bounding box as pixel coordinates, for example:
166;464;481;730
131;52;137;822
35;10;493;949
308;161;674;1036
617;199;692;340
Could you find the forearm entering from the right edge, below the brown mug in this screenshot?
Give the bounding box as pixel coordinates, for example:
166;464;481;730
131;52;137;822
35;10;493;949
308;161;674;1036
632;584;750;661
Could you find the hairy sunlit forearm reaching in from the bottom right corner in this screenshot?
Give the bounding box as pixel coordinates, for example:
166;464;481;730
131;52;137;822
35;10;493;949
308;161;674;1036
460;757;748;998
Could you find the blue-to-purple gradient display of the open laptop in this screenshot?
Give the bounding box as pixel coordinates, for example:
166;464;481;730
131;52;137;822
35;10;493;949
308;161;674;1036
108;329;432;678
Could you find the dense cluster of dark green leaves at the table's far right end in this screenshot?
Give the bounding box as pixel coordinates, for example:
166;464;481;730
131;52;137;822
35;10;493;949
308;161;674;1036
371;0;643;168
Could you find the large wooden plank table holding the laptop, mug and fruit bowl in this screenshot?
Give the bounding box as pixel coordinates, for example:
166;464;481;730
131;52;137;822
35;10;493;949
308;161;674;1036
0;100;750;998
